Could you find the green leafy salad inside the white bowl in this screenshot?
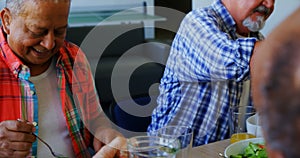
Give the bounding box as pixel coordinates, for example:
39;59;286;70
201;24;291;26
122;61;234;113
230;142;268;158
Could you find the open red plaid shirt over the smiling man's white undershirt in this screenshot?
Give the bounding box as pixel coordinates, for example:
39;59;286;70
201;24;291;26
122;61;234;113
0;29;102;157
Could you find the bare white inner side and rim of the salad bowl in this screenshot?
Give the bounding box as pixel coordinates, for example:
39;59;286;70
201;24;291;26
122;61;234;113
224;138;265;158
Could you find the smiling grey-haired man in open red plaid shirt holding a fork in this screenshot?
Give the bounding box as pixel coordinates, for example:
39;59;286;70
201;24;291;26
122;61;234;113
0;0;126;158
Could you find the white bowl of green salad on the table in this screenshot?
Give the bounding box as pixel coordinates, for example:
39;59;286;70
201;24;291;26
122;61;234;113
224;138;267;158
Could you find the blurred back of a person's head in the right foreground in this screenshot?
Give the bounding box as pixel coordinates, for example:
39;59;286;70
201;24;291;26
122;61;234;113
251;8;300;158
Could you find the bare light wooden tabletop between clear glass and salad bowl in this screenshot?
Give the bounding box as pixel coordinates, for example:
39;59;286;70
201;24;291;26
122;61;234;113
191;139;230;158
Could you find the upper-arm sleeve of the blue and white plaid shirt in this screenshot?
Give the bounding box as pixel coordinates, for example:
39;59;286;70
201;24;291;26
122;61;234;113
169;9;257;82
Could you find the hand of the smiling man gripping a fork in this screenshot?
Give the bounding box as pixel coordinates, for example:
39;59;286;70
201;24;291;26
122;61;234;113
0;120;36;157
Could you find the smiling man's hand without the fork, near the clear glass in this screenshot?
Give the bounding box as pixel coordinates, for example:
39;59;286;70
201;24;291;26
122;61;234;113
93;128;127;158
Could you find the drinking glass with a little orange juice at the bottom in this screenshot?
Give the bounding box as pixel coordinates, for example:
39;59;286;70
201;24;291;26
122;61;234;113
229;106;256;143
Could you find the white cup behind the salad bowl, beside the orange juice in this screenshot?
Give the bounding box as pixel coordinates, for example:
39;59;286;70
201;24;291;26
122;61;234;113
246;114;263;137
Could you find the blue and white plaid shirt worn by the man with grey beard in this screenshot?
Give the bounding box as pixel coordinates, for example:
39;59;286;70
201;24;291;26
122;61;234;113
148;0;263;146
